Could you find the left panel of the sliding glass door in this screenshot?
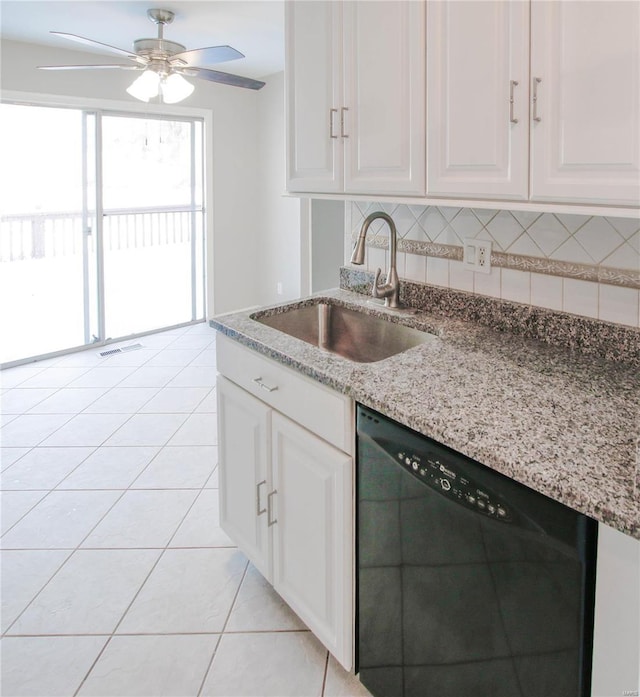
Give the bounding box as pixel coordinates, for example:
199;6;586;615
0;104;95;363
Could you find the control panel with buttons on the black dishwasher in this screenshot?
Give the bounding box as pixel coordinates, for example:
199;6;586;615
396;450;513;522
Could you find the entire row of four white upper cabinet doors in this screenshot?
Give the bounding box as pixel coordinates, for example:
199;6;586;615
286;0;640;207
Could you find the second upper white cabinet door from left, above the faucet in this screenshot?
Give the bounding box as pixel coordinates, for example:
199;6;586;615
342;0;426;195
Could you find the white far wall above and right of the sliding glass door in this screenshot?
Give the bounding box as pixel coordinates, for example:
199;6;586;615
0;41;266;315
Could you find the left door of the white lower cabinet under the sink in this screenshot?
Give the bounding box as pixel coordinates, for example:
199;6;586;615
217;376;271;579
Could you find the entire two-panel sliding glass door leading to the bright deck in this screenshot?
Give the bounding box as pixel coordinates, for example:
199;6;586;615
0;104;204;364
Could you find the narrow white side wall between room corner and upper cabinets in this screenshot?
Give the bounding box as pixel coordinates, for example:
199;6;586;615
254;72;302;305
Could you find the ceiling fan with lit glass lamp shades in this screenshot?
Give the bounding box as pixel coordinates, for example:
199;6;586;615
38;9;265;104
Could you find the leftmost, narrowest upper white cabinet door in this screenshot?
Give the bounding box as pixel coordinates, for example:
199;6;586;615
285;0;344;192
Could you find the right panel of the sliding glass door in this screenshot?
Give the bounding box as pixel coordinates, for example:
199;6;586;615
102;116;203;337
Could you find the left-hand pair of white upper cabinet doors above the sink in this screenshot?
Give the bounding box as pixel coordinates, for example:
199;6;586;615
286;0;425;196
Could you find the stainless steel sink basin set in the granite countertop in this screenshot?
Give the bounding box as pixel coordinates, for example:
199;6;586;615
251;302;435;363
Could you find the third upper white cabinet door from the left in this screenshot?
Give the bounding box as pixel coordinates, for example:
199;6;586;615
427;0;529;200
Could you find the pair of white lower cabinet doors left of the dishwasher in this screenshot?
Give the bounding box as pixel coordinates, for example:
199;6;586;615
217;338;354;670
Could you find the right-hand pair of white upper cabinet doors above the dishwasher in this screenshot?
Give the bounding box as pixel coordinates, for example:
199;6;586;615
427;0;640;205
